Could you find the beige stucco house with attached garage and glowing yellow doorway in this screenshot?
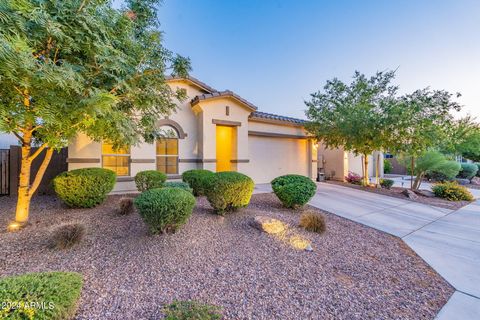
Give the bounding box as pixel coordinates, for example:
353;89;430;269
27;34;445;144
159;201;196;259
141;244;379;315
68;77;317;192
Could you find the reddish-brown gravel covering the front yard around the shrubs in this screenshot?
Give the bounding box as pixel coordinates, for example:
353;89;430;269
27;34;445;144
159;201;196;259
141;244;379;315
0;194;453;319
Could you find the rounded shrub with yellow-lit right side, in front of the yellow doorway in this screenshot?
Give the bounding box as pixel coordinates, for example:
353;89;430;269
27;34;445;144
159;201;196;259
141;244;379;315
206;171;254;214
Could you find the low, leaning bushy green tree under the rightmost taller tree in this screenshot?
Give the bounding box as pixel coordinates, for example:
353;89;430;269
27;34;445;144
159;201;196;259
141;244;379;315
399;151;461;190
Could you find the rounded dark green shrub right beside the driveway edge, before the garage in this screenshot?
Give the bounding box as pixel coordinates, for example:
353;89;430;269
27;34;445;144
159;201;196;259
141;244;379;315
271;174;317;208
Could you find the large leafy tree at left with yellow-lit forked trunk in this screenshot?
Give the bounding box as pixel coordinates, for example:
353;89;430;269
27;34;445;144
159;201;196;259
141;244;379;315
0;0;190;227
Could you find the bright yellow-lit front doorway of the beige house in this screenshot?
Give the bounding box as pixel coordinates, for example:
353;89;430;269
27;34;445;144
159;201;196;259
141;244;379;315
216;125;237;172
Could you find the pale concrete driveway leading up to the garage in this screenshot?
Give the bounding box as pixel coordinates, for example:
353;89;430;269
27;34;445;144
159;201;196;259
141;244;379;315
255;183;480;320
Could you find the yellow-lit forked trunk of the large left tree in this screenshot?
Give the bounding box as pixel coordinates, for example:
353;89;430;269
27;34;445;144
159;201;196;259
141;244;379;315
9;138;53;231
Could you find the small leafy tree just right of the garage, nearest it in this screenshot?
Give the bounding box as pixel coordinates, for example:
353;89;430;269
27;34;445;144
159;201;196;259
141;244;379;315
305;71;397;185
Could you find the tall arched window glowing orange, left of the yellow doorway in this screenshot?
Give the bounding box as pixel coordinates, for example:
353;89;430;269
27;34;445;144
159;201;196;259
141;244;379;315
156;126;178;174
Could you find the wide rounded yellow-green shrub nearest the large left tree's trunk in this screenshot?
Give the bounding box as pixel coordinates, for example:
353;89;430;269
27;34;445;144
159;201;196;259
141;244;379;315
53;168;116;208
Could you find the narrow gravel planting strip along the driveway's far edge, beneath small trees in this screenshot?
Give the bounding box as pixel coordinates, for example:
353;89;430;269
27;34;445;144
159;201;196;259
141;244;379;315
326;180;471;210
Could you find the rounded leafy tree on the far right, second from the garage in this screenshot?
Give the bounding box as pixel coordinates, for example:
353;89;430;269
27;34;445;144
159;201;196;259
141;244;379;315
388;88;461;189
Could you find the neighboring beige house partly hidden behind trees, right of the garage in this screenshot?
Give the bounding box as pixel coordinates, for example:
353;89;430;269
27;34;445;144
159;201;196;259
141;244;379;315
318;144;383;181
